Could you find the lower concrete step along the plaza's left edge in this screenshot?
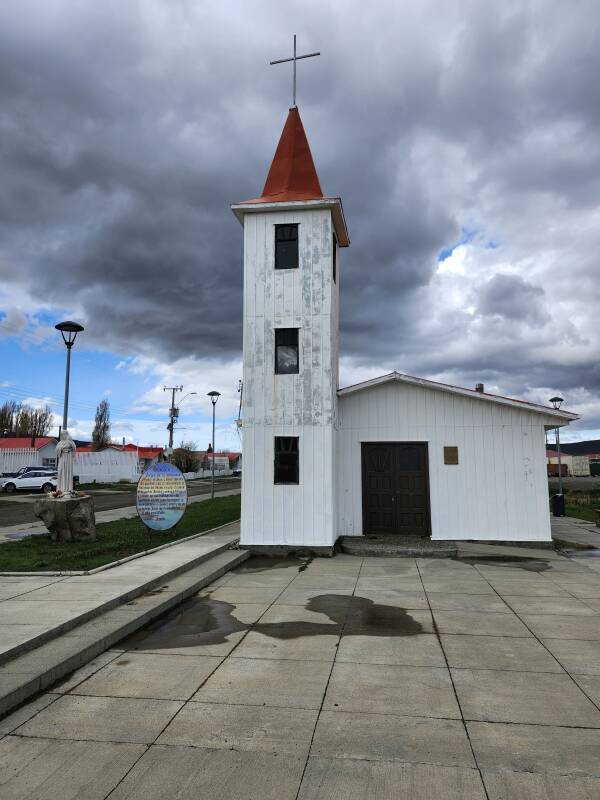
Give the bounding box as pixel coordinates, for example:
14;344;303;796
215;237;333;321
0;550;249;717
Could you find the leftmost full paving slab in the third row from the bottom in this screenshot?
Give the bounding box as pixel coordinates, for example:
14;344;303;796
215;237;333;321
71;652;222;700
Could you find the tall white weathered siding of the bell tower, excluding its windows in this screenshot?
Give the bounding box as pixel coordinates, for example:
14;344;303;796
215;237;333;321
241;209;339;546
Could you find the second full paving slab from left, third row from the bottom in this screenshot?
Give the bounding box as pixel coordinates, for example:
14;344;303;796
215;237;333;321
192;658;331;708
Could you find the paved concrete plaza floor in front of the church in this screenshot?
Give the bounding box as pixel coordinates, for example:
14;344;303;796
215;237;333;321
0;545;600;800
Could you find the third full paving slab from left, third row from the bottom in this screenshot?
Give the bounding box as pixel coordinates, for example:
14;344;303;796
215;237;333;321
323;662;460;719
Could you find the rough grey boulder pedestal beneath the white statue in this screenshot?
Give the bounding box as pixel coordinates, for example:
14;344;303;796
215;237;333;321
33;495;96;542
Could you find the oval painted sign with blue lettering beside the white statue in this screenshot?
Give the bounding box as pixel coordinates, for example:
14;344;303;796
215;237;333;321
136;461;187;531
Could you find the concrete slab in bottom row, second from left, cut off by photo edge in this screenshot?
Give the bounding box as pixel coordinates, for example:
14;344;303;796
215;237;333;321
110;745;305;800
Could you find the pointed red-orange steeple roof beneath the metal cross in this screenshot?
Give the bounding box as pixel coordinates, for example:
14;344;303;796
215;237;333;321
245;107;323;203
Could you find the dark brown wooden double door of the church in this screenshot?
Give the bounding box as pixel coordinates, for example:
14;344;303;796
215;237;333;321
362;442;431;536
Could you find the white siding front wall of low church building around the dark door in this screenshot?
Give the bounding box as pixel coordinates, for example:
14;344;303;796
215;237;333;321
336;383;550;541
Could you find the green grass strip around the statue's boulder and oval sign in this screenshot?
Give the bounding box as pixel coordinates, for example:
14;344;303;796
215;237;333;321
0;495;240;572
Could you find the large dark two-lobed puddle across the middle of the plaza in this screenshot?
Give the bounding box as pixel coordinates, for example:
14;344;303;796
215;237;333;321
123;594;423;650
